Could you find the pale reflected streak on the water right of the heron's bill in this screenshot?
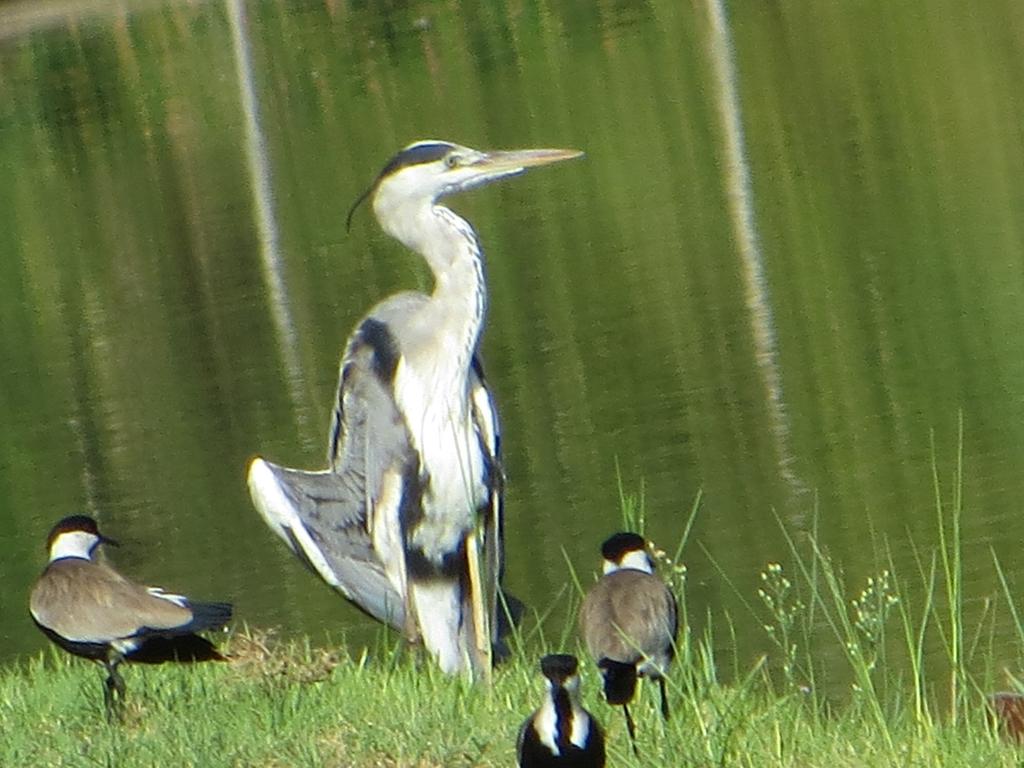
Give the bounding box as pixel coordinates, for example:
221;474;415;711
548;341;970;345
708;0;807;494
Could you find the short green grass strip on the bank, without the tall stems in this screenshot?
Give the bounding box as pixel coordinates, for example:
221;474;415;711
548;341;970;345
0;614;1020;768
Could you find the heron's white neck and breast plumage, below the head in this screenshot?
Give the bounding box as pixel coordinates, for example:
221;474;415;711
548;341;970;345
372;205;494;564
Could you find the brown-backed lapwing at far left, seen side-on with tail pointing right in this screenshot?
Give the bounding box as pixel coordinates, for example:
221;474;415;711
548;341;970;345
29;515;231;717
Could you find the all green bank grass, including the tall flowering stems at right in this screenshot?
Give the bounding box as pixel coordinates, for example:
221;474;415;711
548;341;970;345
6;428;1024;768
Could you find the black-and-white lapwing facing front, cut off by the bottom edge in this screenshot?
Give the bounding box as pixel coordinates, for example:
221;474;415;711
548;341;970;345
516;653;605;768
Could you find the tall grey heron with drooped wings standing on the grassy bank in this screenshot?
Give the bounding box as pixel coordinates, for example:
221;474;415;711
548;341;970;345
249;140;582;676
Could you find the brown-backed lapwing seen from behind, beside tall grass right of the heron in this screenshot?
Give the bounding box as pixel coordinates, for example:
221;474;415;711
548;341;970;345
580;532;679;751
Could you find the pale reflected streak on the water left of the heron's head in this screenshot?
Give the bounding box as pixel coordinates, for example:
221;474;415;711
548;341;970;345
226;0;309;444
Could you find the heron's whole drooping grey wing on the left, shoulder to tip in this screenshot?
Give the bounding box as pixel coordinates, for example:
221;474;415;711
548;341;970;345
249;309;419;629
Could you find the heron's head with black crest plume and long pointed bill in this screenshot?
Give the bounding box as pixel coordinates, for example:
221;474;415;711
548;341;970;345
346;139;583;237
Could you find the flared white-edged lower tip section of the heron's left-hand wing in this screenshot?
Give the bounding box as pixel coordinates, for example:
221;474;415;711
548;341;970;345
249;459;406;630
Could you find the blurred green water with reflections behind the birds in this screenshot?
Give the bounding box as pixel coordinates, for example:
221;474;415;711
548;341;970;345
0;0;1024;696
